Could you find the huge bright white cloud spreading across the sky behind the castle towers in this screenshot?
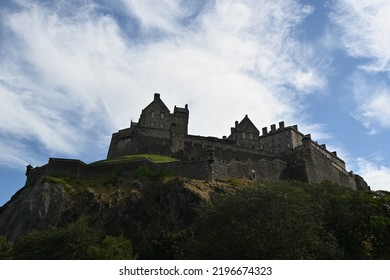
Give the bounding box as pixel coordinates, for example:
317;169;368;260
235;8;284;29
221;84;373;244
0;0;325;166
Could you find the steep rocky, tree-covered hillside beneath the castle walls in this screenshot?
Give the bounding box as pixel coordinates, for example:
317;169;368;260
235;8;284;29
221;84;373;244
0;173;390;259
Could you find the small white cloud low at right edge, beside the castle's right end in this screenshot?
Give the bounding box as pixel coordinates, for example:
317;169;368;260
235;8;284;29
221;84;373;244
357;158;390;191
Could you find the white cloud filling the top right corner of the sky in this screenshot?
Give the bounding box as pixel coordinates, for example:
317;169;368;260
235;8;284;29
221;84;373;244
331;0;390;72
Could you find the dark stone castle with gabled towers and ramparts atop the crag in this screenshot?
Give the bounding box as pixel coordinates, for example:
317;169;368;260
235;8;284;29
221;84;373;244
27;93;370;190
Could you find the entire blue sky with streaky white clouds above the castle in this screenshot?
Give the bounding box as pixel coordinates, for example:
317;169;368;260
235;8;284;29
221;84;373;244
0;0;390;205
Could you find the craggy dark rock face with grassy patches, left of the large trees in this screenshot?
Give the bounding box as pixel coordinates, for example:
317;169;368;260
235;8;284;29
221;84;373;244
0;177;222;254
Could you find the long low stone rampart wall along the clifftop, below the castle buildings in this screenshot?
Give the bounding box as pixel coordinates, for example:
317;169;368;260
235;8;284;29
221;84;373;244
26;152;369;190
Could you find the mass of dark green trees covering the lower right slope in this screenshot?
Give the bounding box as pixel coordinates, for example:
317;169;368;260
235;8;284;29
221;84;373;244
186;181;390;259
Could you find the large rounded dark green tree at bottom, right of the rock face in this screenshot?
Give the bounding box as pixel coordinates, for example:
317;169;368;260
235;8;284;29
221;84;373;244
193;182;340;259
